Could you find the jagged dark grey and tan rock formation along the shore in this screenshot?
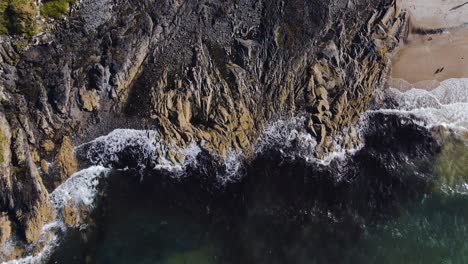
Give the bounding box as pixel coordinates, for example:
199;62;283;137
0;0;406;258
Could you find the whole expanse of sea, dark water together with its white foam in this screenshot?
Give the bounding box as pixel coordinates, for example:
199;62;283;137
5;79;468;264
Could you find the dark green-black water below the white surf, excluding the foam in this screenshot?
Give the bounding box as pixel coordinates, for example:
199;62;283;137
50;115;468;264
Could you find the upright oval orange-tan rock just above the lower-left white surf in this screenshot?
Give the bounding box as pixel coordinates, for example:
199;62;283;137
55;136;78;180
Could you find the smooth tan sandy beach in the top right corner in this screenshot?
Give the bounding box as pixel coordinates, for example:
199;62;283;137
389;0;468;90
